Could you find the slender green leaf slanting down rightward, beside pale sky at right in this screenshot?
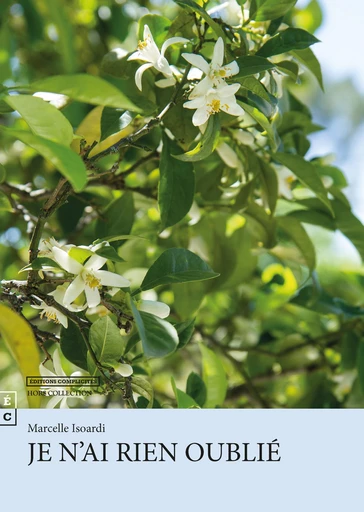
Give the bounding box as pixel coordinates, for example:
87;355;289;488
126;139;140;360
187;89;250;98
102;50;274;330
273;153;333;214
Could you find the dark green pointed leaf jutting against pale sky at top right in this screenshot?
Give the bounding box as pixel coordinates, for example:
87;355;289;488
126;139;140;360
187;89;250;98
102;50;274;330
257;28;319;57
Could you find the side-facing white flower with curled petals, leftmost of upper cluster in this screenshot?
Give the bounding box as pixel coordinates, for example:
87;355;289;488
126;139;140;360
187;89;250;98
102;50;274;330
128;25;189;91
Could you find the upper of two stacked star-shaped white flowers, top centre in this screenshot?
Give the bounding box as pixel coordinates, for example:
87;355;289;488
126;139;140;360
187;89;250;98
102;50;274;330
182;37;240;88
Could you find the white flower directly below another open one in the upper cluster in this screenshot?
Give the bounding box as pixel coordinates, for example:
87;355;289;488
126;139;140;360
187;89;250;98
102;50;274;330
183;79;244;126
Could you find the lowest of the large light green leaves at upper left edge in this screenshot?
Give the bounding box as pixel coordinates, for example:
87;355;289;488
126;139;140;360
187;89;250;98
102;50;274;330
0;126;87;192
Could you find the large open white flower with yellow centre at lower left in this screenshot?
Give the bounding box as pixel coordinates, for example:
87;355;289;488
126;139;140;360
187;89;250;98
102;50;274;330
52;247;130;308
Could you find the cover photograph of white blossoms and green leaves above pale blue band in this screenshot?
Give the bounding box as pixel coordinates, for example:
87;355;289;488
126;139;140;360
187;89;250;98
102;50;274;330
0;0;364;412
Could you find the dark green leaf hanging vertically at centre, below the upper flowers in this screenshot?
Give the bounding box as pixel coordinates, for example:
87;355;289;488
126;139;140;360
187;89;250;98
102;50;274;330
158;134;195;230
